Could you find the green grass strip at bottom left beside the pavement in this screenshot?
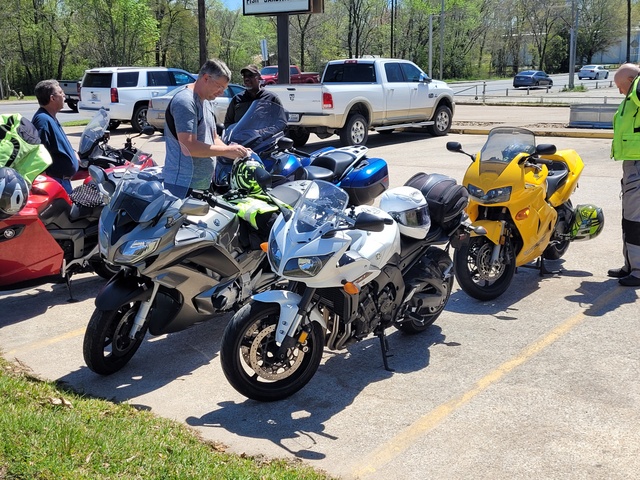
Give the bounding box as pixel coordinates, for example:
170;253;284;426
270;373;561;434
0;357;338;480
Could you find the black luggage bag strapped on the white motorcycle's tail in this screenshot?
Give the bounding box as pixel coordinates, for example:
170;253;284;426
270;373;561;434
405;172;469;230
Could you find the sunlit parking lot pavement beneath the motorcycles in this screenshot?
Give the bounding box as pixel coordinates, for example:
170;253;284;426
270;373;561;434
0;106;640;479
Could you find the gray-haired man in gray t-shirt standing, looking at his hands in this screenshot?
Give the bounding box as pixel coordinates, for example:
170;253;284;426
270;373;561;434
163;59;249;197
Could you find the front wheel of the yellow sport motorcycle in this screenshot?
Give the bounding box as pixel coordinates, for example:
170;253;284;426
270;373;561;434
453;236;516;300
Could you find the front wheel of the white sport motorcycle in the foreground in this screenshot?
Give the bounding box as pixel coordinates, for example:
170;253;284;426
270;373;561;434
220;302;324;402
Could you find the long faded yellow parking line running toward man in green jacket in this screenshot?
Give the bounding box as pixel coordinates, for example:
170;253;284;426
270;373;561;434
353;288;622;478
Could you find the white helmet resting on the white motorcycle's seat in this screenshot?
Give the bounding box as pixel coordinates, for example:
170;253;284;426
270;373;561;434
380;186;431;240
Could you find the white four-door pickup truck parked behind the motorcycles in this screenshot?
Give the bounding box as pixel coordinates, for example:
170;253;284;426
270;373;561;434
265;58;455;147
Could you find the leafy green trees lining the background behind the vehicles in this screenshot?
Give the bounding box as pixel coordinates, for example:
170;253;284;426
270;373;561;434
0;0;640;98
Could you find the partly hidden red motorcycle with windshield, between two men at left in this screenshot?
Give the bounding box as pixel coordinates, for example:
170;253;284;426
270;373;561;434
71;108;156;180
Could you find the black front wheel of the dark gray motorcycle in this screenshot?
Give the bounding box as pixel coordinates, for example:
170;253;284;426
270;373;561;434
82;302;147;375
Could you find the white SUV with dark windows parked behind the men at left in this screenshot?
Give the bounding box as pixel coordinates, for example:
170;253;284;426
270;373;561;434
78;67;196;132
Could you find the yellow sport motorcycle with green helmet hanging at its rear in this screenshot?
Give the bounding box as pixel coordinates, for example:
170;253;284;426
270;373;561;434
447;127;604;300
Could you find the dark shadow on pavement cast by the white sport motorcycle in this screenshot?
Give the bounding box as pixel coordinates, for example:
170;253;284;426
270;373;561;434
186;325;446;460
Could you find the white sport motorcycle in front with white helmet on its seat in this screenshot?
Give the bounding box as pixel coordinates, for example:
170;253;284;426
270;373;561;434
220;181;468;401
